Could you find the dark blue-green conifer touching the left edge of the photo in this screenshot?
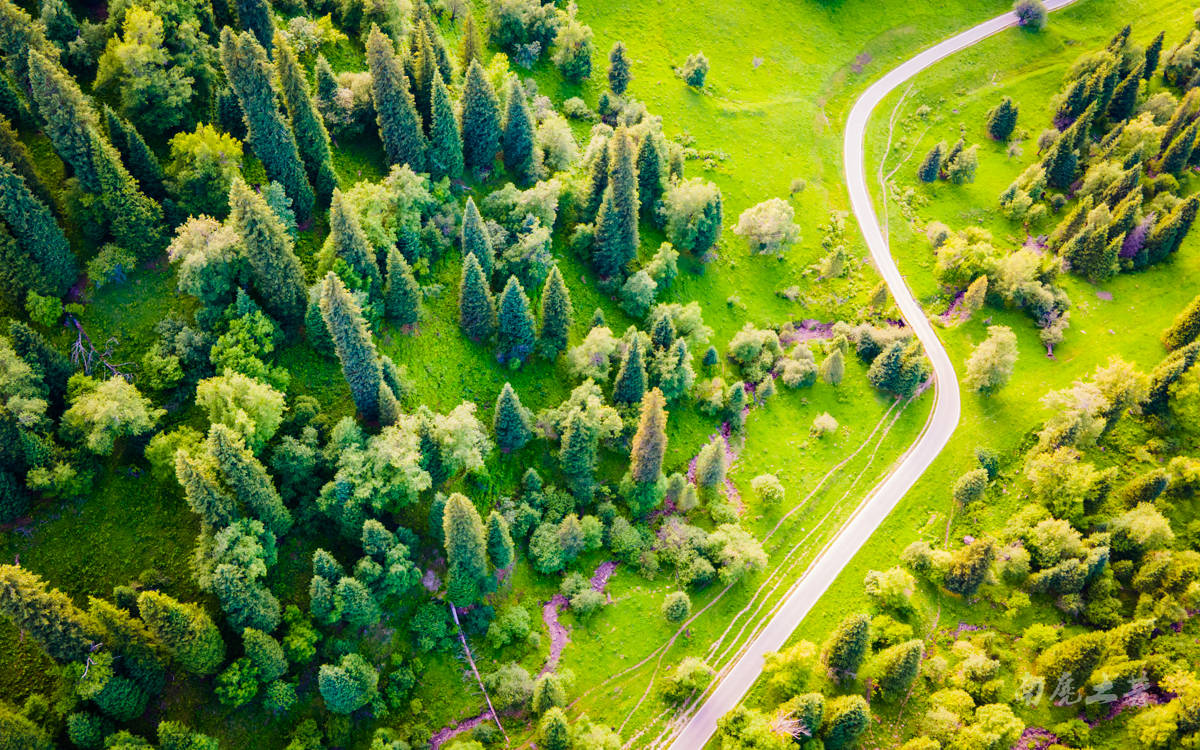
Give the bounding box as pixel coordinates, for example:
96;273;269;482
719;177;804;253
0;158;79;296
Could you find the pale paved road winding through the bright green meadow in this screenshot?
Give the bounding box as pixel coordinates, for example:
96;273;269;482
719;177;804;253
671;0;1075;750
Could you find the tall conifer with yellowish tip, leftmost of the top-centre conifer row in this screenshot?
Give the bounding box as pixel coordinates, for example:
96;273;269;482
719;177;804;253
367;25;426;172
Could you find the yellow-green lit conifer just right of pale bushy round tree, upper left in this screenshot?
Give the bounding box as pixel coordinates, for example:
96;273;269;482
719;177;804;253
229;178;307;325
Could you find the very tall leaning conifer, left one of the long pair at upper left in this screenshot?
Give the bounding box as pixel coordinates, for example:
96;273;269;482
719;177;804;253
221;26;314;222
